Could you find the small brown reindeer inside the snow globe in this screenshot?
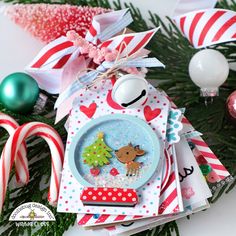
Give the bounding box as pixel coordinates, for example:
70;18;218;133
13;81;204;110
115;143;145;176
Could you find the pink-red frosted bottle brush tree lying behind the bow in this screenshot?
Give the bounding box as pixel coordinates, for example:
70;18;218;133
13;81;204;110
6;4;110;43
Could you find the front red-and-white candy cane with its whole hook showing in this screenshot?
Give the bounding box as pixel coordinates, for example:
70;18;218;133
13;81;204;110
0;122;64;211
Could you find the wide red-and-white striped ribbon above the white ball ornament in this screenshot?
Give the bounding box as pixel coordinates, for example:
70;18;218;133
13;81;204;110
173;9;236;48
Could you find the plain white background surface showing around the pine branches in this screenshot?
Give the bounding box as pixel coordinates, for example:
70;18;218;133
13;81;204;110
0;0;236;236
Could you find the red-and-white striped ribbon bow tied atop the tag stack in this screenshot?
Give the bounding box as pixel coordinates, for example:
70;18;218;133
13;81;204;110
26;9;162;121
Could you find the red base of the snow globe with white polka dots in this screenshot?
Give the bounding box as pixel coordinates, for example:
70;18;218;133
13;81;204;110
80;187;138;206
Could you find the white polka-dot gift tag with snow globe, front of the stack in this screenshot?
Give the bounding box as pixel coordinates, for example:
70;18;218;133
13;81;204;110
58;81;173;216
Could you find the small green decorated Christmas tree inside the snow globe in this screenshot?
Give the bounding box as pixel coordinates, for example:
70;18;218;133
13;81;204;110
82;132;112;176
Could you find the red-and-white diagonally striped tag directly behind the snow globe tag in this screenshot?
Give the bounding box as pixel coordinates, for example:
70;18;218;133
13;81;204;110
77;145;183;227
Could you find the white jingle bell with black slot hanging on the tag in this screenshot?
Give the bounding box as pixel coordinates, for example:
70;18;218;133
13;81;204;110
112;74;148;108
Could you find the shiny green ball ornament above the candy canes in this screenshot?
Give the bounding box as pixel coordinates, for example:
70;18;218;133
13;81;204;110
0;72;39;114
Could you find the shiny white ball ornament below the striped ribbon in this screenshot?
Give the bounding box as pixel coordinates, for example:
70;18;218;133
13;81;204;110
189;49;229;97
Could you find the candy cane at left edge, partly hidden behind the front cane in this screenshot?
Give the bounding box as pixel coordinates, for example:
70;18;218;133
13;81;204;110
0;113;29;184
